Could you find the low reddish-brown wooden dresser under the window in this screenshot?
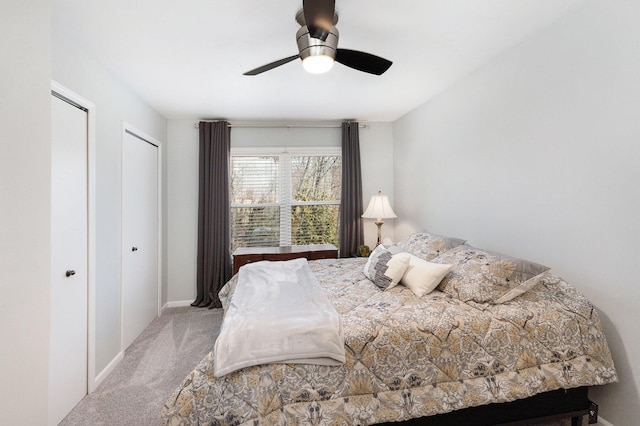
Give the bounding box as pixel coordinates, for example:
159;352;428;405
233;244;338;274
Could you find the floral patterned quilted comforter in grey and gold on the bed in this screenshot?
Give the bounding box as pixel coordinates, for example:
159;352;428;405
162;258;617;426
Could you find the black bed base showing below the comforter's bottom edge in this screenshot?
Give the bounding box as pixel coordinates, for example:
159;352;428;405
380;386;597;426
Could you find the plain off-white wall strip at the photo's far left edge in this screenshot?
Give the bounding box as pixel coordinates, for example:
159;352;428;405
0;0;51;425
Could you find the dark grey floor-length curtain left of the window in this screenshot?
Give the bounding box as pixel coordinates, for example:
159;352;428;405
191;121;231;308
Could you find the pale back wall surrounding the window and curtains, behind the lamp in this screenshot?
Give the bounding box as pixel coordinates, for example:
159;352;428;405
167;120;393;302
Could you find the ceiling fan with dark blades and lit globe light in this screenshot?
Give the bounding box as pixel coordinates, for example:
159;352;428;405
244;0;393;75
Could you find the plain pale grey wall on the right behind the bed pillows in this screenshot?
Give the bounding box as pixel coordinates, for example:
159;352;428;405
393;0;640;426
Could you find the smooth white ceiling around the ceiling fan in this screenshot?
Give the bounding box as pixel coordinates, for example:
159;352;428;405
53;0;584;121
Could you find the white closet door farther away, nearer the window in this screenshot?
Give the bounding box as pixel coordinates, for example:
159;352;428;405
122;130;159;349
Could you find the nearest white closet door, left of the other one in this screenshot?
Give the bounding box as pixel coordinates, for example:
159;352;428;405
49;92;88;425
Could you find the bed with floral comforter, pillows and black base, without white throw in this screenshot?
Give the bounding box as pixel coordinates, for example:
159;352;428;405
161;231;617;425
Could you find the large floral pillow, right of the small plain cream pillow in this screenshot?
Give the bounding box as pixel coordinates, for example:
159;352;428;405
434;244;549;303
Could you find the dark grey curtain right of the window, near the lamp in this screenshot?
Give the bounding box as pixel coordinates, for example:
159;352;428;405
340;121;364;257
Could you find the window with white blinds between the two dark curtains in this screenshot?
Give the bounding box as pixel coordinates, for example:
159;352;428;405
231;149;342;250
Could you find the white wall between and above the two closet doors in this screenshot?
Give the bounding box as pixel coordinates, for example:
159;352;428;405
52;28;167;374
